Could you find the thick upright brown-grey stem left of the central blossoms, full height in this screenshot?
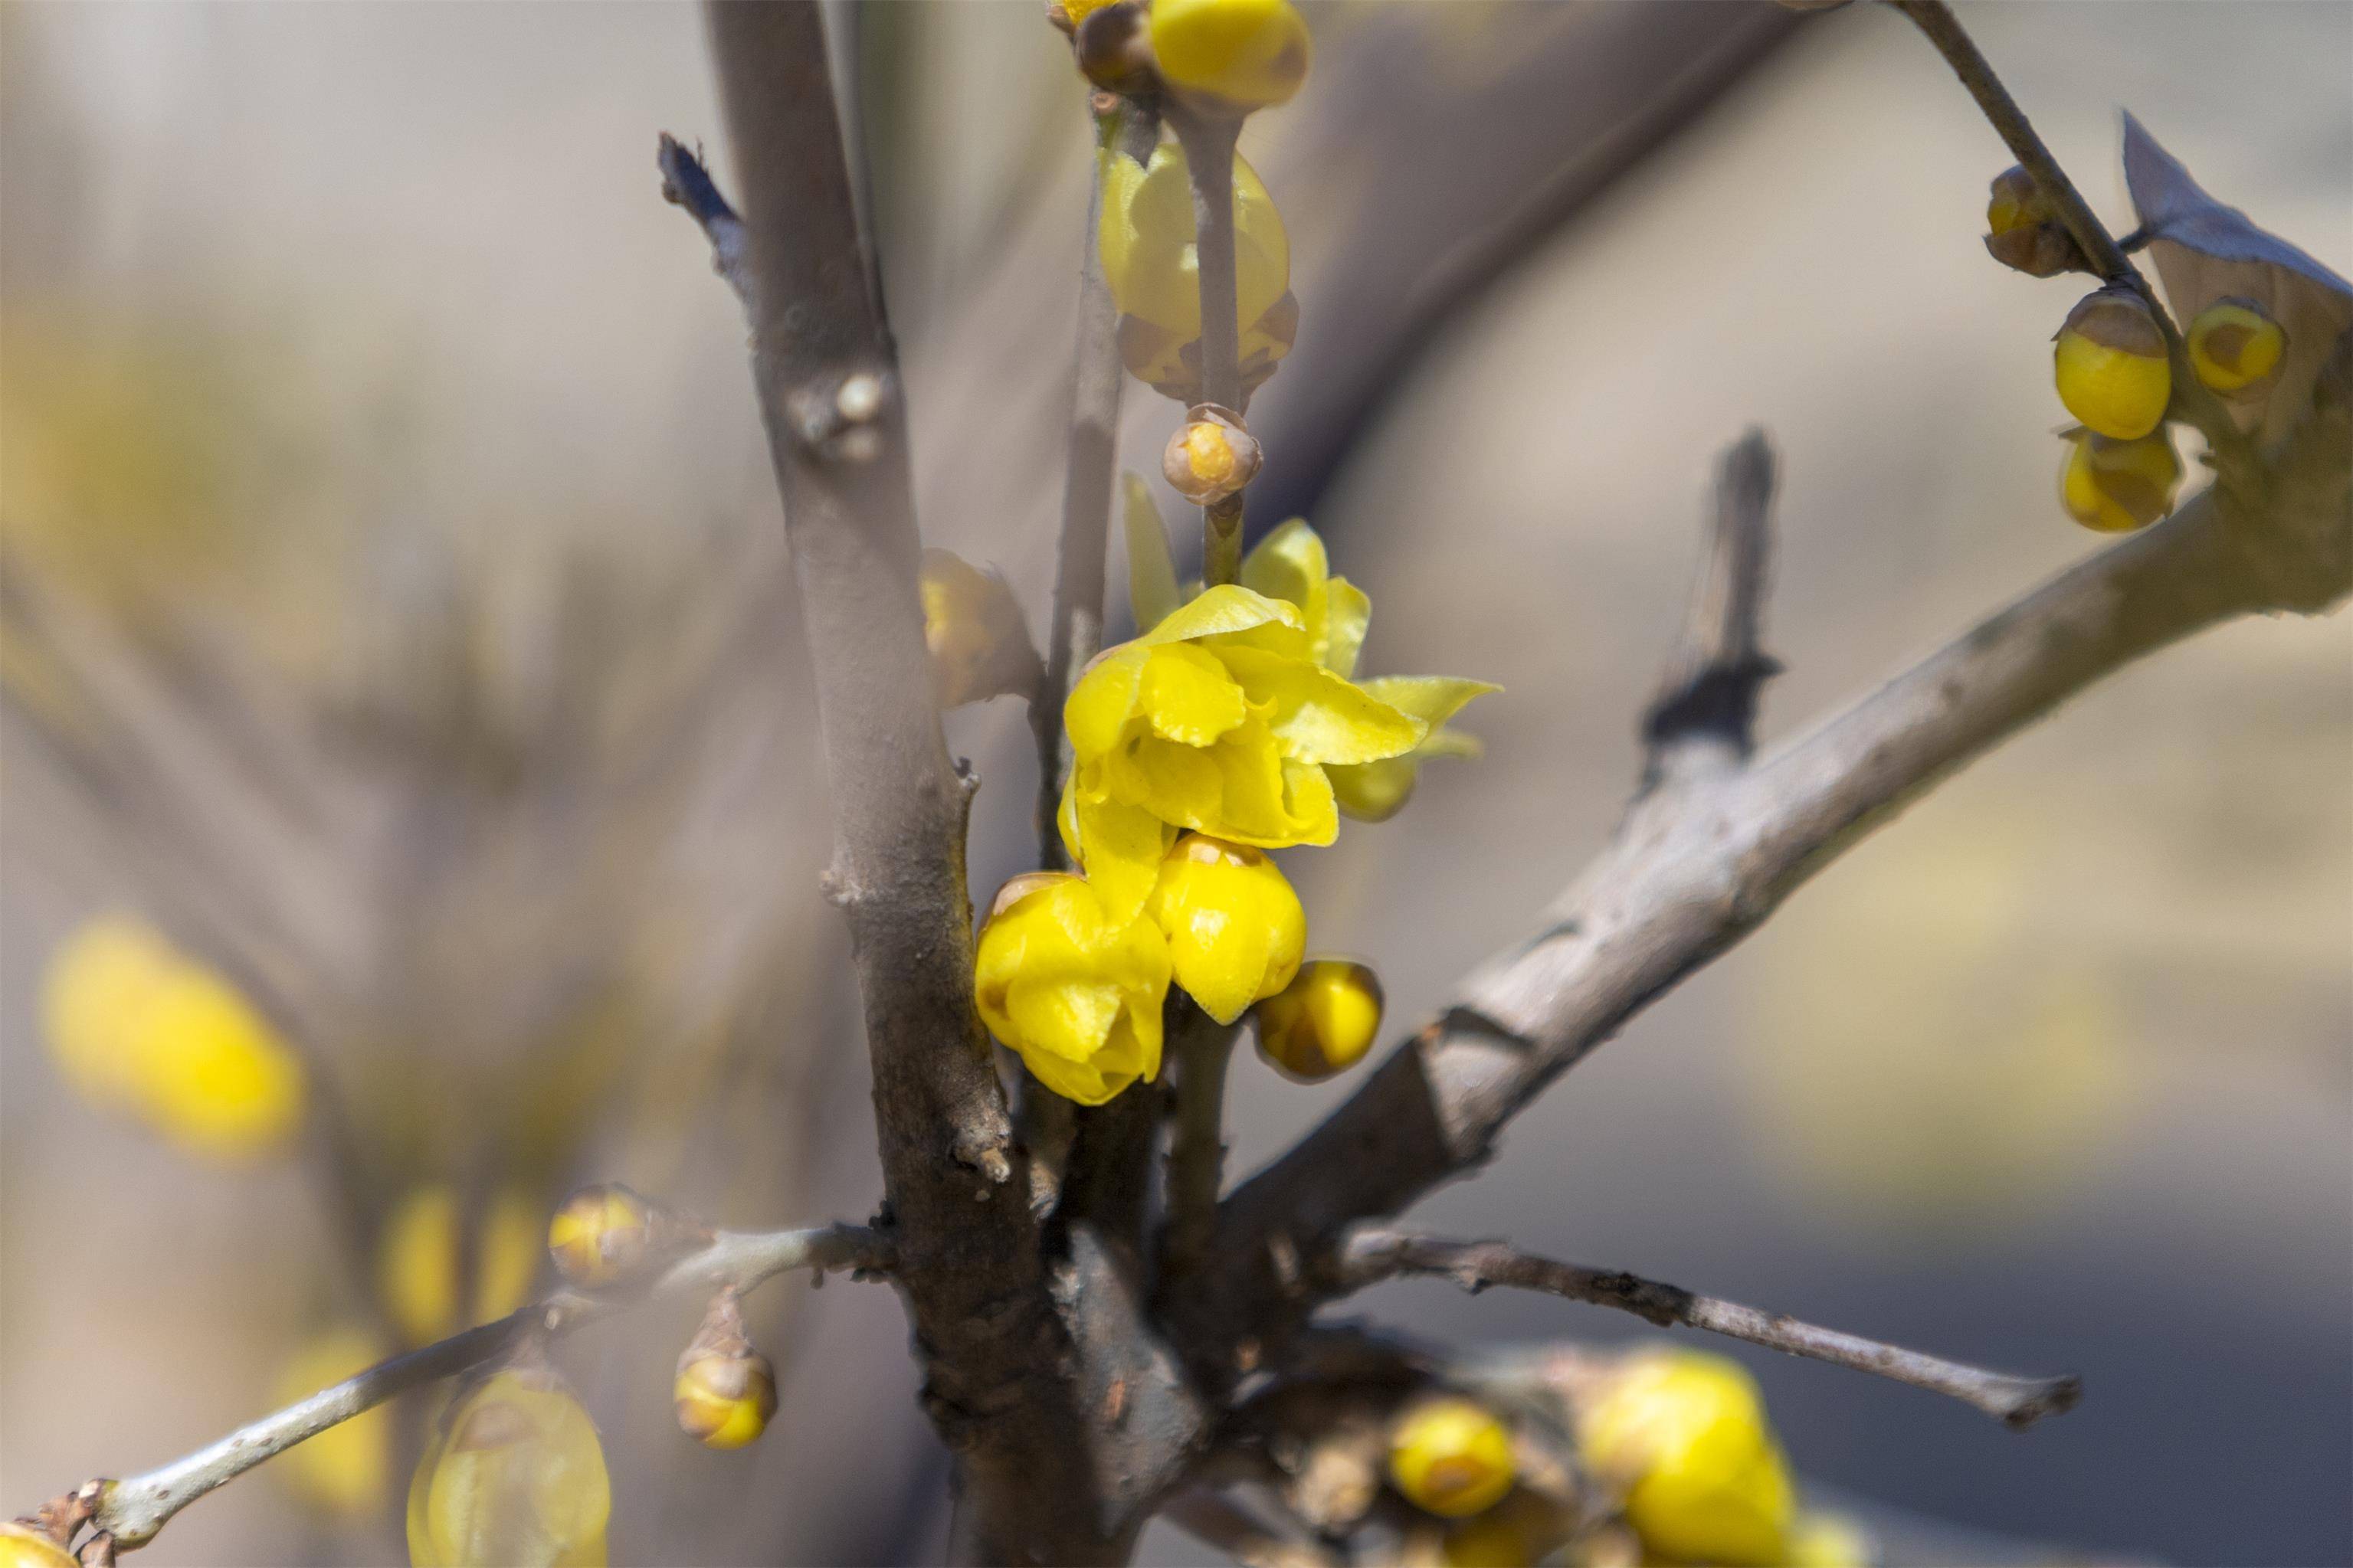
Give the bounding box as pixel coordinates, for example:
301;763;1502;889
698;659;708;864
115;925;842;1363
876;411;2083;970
706;2;1204;1563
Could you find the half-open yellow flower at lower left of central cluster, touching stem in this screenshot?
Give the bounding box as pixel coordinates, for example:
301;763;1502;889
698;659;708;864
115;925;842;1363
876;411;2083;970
974;872;1169;1105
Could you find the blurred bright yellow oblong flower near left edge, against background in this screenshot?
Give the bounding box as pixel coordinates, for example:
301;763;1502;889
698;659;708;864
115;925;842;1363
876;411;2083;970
42;915;308;1161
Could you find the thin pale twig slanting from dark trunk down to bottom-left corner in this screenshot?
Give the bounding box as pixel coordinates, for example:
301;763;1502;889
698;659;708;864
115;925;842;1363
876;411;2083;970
92;1225;892;1547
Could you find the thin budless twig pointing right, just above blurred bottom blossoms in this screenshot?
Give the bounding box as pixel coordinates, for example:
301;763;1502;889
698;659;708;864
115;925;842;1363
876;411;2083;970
1332;1229;2083;1429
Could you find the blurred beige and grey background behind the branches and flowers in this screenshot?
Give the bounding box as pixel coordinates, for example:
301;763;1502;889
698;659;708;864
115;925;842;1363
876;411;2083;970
0;0;2353;1568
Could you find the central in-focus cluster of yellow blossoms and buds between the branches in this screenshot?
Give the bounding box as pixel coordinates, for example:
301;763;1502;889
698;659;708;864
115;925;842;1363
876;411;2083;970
976;519;1494;1105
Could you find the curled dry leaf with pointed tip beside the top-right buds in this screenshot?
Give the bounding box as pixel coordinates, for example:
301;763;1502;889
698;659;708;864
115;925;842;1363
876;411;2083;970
2125;113;2353;442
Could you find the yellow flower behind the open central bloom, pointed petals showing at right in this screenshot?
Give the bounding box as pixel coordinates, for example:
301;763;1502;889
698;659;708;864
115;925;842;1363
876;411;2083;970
1242;517;1501;823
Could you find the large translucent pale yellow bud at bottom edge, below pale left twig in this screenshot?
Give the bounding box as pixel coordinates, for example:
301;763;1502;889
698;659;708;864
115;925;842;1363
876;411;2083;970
409;1368;611;1568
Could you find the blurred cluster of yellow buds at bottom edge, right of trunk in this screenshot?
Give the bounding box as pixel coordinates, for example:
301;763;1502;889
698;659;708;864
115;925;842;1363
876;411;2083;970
1388;1350;1870;1568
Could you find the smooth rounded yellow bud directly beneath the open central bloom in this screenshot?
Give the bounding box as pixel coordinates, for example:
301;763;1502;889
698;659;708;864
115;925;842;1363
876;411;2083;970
1144;832;1308;1023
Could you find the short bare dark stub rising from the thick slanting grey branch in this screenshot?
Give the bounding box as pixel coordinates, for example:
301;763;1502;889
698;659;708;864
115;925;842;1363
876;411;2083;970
1643;430;1781;790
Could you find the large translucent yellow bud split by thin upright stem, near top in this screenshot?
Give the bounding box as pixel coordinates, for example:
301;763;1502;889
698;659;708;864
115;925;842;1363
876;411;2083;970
1099;141;1292;343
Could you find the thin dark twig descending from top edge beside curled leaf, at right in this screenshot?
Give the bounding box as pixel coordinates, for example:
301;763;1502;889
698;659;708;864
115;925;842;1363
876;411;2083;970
1887;0;2263;506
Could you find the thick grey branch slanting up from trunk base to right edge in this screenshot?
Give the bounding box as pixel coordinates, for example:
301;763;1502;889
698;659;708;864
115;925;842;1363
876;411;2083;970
1177;381;2353;1380
